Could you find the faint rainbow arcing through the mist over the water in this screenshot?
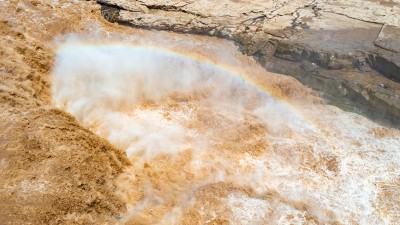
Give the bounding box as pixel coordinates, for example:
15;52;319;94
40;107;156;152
56;42;336;150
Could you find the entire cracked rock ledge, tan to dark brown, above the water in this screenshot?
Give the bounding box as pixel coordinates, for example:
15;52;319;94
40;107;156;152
98;0;400;127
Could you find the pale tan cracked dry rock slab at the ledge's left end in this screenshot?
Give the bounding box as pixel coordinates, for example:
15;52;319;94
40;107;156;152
98;0;312;37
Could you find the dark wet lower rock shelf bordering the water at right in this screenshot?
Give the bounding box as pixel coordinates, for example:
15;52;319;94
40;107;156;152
268;55;400;127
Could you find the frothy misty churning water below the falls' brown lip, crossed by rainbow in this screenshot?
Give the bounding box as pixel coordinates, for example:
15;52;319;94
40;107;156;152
53;30;400;224
